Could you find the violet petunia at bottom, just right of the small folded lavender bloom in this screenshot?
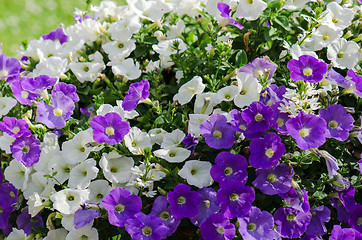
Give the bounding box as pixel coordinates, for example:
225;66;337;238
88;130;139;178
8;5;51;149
102;188;142;227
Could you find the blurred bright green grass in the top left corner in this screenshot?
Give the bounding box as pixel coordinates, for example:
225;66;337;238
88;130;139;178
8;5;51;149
0;0;101;57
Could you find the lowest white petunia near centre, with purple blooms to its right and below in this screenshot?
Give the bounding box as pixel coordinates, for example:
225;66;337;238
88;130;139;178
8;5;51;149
178;160;213;188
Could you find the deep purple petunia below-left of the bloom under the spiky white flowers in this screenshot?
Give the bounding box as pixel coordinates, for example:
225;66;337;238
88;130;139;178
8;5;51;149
249;132;285;169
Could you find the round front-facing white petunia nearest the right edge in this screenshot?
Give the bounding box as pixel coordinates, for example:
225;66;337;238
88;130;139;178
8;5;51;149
327;38;359;69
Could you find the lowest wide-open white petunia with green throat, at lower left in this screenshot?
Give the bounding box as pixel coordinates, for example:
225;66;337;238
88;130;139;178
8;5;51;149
50;188;90;214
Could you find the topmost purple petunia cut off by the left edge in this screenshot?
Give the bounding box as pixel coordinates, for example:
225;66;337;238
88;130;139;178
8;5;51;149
0;54;21;82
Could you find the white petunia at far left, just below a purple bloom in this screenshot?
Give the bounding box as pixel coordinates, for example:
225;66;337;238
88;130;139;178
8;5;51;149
4;159;32;191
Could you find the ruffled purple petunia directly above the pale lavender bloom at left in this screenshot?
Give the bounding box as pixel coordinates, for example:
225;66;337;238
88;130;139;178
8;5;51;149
20;75;58;94
